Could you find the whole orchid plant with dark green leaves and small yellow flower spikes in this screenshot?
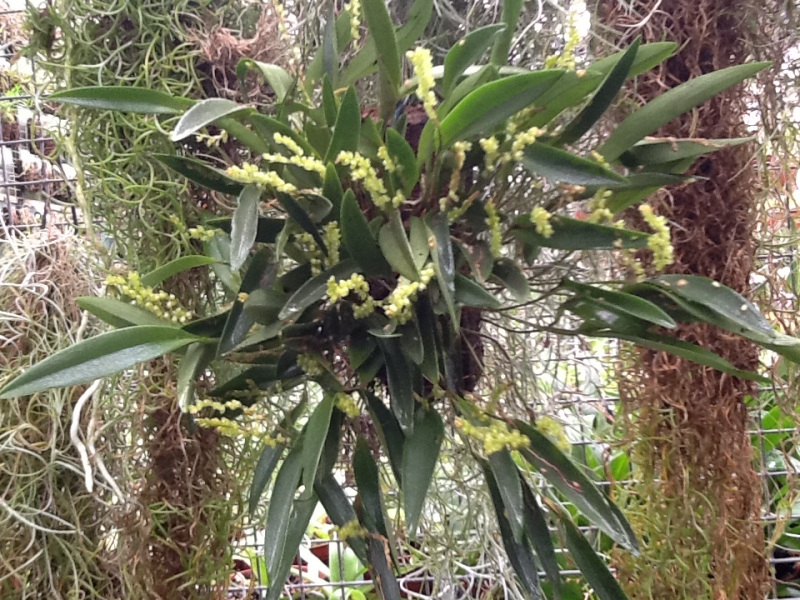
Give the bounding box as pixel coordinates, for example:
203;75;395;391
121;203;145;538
0;0;800;598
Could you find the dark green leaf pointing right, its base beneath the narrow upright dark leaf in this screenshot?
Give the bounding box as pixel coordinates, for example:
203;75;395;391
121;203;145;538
521;142;626;186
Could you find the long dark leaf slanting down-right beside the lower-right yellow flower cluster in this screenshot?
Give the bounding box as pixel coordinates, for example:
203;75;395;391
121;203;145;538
514;420;639;554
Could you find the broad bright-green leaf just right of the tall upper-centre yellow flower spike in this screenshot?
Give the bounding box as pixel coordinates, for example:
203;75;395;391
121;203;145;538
439;70;563;148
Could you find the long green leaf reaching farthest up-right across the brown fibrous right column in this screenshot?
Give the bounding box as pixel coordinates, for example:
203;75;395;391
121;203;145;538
599;62;772;161
